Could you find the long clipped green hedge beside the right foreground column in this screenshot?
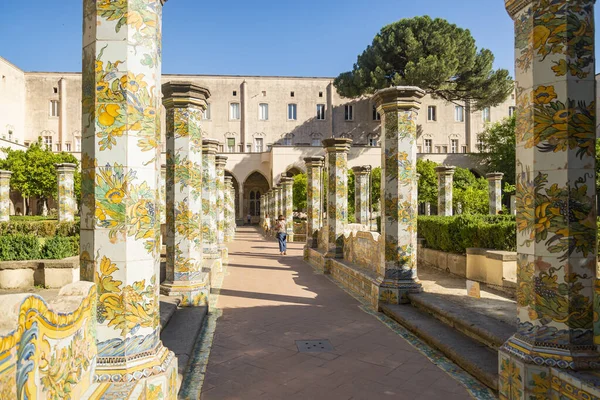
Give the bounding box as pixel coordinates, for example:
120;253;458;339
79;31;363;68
417;215;517;254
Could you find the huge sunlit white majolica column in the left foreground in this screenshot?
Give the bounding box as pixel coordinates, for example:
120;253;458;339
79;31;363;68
80;0;177;390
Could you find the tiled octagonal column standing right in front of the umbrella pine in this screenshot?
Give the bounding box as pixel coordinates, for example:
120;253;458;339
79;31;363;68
374;86;425;304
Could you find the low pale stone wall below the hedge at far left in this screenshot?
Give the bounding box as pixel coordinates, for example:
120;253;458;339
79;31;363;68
0;257;79;289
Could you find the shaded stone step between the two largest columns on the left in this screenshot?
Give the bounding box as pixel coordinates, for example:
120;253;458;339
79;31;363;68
160;306;208;382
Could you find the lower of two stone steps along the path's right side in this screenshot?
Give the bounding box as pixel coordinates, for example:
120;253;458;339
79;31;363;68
381;304;498;391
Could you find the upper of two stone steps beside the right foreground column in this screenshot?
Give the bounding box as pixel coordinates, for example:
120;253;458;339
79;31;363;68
409;293;517;350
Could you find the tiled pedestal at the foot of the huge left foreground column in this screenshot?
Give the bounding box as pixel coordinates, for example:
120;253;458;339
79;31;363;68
81;344;181;400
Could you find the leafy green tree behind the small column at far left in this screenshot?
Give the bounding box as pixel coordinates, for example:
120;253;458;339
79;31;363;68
0;138;81;211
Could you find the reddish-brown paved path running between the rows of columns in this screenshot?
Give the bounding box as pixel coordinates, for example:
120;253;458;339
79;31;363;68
202;227;470;400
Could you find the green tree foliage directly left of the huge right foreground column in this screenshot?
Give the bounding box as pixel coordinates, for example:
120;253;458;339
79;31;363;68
471;116;516;185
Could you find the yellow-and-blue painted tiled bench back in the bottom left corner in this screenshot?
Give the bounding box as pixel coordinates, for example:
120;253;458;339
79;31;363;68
0;282;97;399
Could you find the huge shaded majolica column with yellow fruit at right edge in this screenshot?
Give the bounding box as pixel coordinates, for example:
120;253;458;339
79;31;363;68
499;0;600;399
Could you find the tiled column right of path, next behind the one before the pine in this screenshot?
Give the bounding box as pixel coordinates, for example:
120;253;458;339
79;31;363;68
323;138;352;258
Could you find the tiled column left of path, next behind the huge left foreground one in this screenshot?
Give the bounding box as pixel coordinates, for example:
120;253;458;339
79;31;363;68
161;82;210;306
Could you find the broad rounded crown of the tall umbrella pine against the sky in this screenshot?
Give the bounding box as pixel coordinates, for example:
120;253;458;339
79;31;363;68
334;16;513;108
